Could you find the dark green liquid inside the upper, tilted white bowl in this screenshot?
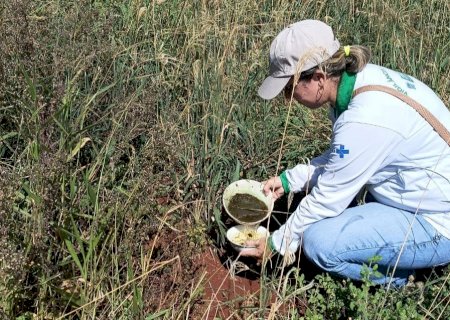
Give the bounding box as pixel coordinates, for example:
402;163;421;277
228;193;269;223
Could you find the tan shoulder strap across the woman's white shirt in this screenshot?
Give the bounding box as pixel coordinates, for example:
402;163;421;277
353;85;450;146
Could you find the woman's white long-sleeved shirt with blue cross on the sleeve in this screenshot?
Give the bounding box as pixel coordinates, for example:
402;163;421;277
272;64;450;254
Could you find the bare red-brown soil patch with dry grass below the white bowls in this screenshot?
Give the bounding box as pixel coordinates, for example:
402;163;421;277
143;220;312;320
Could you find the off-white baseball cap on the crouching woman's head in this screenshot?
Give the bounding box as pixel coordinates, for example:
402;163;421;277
258;20;340;100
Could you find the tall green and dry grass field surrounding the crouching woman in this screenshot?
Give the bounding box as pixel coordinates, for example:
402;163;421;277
0;0;450;320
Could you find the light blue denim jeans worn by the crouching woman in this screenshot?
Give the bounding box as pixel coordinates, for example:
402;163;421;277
303;202;450;287
